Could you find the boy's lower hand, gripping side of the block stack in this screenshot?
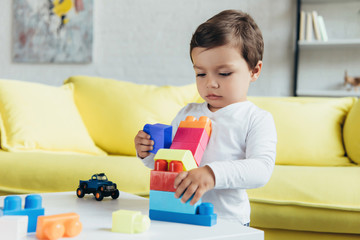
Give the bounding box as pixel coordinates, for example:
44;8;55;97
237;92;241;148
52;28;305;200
174;166;215;205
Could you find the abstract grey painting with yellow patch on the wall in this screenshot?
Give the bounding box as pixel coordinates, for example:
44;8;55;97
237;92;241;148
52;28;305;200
12;0;93;63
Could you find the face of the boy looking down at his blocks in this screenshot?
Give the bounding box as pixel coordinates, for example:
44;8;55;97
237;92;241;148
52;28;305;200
191;45;262;112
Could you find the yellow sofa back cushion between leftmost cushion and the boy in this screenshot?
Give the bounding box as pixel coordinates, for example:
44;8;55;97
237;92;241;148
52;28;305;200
65;76;197;155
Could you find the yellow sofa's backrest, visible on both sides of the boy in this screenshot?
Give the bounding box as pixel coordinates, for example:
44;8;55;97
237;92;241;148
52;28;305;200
0;76;360;166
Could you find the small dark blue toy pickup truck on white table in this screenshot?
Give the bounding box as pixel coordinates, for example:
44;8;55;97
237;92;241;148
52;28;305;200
76;173;120;201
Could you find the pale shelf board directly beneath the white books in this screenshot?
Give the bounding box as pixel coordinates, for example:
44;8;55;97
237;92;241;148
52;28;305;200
298;39;360;49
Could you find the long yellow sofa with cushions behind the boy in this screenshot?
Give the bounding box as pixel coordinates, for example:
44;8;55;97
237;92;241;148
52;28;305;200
0;76;360;240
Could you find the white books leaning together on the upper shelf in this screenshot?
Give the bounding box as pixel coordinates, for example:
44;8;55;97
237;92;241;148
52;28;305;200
299;11;328;42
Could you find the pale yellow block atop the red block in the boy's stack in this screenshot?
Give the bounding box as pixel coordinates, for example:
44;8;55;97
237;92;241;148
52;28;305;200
154;148;197;171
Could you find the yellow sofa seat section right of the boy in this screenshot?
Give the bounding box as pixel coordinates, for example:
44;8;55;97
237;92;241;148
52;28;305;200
248;166;360;234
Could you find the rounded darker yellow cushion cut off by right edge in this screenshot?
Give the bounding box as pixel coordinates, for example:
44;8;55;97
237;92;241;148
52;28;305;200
344;98;360;164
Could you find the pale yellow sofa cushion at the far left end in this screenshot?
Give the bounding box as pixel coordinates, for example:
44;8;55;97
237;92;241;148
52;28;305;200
0;80;105;155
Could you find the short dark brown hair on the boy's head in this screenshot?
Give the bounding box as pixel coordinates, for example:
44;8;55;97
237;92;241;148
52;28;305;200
190;10;264;69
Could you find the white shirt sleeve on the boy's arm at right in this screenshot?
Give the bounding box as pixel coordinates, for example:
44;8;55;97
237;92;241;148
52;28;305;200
208;112;277;189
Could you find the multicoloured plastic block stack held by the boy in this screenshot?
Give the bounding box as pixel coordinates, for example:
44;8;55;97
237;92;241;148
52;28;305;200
144;116;217;226
